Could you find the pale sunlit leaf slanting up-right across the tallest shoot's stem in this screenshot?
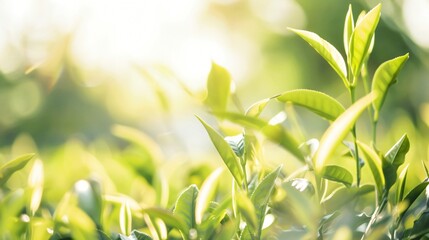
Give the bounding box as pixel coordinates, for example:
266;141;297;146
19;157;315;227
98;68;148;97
314;94;374;172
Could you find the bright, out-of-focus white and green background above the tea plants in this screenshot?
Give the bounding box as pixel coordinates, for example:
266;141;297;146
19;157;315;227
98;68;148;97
0;0;429;172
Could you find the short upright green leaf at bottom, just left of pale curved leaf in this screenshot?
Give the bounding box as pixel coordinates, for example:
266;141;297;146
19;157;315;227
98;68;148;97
173;184;198;232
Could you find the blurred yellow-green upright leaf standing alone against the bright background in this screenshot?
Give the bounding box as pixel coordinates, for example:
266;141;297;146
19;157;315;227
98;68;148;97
205;62;231;111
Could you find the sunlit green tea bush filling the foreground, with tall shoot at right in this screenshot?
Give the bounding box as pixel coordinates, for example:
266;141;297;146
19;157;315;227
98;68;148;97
0;5;429;239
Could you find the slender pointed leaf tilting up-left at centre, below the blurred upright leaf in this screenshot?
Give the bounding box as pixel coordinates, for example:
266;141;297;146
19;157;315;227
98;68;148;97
197;116;244;185
